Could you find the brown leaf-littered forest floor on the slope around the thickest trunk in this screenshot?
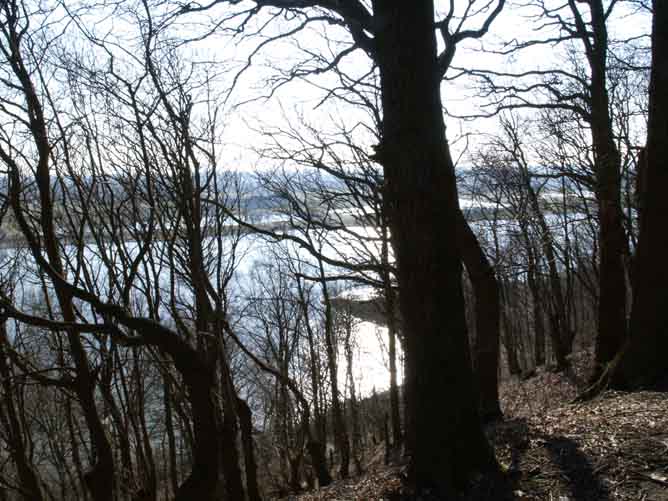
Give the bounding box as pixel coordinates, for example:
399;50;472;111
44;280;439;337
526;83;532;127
286;353;668;501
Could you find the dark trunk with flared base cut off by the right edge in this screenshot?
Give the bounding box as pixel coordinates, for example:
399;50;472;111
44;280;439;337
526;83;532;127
612;0;668;389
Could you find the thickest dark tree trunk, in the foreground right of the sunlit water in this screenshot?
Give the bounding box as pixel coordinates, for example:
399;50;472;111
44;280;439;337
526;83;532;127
373;0;496;497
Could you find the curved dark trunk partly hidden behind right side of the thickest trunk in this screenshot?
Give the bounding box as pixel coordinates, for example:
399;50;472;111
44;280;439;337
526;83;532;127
457;211;502;421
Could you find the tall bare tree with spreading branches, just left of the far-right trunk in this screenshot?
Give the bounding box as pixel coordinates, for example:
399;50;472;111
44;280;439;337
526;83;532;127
456;0;642;374
